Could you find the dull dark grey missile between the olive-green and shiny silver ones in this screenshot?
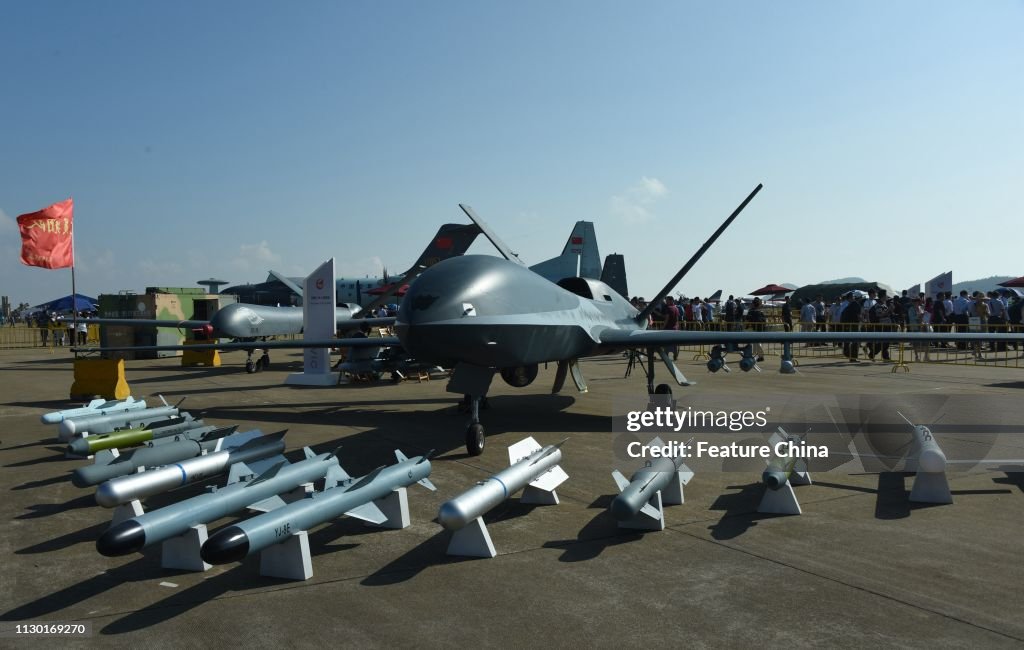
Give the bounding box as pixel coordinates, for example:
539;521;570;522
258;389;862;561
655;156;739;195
71;425;239;487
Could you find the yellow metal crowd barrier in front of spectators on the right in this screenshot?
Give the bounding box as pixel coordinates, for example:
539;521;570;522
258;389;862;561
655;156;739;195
651;322;1024;372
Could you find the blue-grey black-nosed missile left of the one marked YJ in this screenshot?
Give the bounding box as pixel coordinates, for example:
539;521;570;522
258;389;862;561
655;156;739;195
96;447;341;557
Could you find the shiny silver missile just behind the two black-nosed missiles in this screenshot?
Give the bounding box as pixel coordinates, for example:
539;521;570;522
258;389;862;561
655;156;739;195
96;430;287;508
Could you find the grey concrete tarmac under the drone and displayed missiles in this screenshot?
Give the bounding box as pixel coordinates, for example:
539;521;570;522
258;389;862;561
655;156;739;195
0;350;1024;648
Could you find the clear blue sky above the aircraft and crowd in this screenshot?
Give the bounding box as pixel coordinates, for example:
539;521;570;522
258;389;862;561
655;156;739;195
0;0;1024;304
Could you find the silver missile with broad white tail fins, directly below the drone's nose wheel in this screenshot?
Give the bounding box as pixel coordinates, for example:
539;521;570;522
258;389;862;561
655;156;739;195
437;438;568;530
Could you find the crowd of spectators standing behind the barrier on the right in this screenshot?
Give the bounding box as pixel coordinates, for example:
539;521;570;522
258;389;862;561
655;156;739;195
630;291;1024;361
